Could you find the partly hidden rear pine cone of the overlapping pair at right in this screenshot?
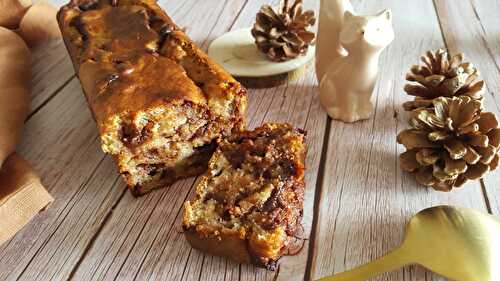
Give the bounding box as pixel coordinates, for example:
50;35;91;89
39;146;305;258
403;49;484;111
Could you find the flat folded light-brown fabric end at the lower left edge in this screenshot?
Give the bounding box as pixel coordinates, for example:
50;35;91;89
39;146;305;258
0;153;54;245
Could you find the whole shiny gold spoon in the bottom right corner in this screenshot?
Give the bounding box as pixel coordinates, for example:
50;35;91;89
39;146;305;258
318;203;500;281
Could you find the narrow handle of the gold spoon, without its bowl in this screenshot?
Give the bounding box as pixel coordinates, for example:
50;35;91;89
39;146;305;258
317;249;410;281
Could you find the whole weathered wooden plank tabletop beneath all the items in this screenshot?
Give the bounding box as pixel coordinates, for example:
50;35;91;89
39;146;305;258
0;0;500;281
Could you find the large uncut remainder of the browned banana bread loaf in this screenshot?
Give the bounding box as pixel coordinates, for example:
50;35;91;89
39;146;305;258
58;0;246;195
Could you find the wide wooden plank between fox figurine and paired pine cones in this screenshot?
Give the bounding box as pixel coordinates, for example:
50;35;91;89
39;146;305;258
311;0;485;280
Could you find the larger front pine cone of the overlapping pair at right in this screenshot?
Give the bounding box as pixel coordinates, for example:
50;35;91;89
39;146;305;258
397;96;500;191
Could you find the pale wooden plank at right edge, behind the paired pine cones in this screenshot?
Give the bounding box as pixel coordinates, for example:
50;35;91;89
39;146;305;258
435;0;500;215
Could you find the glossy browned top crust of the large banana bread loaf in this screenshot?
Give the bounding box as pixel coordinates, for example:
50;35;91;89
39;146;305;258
58;0;244;129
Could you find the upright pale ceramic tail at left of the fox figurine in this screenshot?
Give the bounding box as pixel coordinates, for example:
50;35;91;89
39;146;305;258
316;0;353;81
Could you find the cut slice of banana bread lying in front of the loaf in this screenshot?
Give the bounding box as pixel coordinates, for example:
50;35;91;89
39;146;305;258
183;124;306;270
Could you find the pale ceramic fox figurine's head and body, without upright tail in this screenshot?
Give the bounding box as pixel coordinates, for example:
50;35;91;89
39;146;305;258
319;10;394;123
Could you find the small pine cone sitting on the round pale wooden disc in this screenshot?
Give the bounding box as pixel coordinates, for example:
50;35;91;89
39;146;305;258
252;0;316;62
